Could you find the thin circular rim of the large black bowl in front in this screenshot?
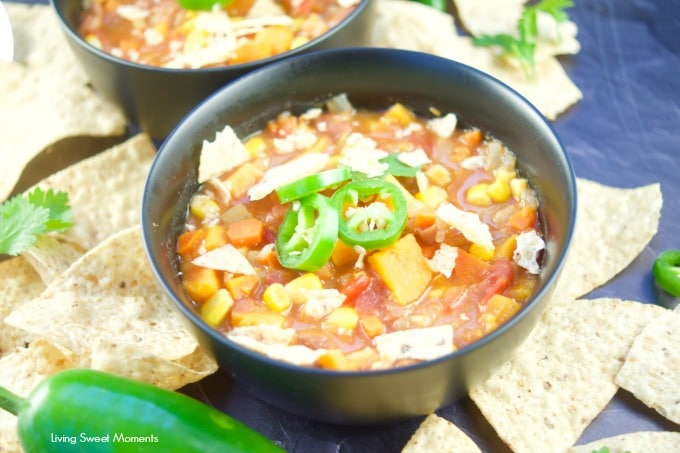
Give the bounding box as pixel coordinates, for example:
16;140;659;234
141;47;578;377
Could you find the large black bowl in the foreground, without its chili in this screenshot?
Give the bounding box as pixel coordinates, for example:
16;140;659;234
142;49;576;424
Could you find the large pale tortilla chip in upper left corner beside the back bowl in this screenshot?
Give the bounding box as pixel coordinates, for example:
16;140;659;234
0;2;126;200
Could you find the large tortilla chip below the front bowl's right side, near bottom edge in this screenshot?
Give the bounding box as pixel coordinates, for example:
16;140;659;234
470;299;664;453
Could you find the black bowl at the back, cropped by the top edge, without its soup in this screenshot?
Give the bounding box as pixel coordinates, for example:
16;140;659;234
50;0;373;139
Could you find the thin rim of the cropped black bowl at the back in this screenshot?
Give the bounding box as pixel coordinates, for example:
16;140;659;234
49;0;376;74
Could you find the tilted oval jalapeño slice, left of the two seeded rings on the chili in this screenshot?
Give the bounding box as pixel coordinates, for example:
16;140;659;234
275;193;338;272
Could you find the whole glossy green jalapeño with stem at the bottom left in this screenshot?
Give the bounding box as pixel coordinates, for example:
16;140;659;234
0;368;283;453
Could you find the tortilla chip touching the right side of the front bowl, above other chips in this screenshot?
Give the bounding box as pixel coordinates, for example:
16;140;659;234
554;178;663;302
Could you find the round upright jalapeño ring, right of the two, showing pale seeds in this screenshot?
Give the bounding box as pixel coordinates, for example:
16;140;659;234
331;178;407;250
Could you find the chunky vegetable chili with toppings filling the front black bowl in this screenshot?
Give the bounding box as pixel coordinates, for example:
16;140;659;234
177;96;545;370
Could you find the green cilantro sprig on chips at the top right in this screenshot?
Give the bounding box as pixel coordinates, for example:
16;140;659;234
472;0;574;78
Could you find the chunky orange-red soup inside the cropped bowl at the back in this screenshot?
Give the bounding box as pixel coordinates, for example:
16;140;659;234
78;0;356;68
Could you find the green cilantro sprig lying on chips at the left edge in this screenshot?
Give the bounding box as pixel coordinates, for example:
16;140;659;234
0;187;73;256
